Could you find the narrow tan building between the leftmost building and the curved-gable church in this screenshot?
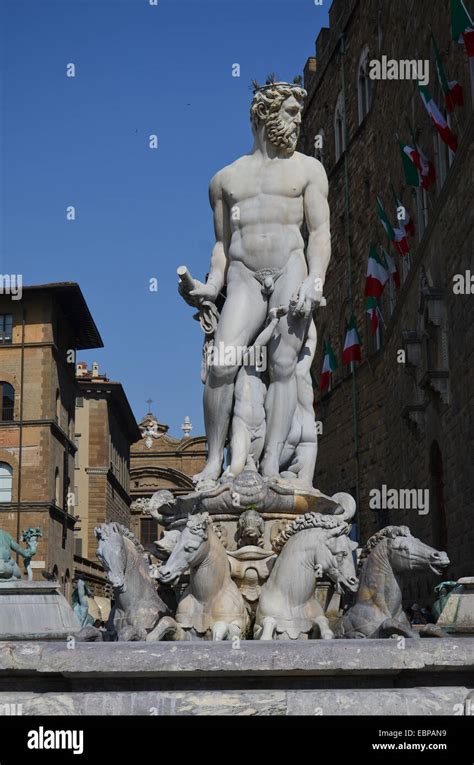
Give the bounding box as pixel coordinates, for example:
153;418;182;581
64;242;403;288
74;362;140;594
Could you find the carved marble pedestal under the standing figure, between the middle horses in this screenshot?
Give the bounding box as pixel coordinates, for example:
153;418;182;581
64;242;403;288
146;470;356;624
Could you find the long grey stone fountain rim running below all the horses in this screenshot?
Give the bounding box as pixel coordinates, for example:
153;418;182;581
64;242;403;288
0;638;474;716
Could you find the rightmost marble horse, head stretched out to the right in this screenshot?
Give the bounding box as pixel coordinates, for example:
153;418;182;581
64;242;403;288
336;526;449;638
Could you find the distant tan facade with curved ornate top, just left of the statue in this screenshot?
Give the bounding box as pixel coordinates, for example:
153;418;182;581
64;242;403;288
130;412;207;550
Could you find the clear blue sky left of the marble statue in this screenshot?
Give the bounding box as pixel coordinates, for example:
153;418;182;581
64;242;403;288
0;0;330;437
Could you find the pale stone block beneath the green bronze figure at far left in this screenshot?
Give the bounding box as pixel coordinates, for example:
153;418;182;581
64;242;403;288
0;579;80;640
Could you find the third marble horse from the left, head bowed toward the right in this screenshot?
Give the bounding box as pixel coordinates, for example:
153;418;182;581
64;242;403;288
254;508;357;640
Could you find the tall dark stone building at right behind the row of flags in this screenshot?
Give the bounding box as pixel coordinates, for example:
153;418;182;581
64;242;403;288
300;0;474;604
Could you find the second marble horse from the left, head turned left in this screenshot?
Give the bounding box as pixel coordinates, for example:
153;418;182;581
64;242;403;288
151;513;248;640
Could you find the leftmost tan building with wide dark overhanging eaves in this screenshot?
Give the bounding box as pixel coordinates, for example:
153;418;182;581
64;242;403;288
0;282;103;597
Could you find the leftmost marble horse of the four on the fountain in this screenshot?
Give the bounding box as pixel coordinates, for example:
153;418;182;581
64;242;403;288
95;523;170;640
